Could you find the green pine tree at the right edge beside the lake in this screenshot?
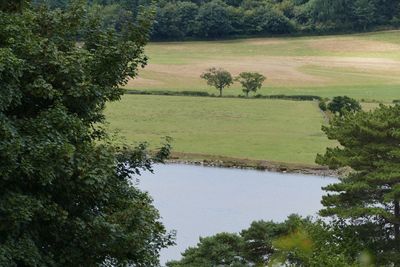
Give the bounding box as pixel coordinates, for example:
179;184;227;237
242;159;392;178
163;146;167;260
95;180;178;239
317;105;400;262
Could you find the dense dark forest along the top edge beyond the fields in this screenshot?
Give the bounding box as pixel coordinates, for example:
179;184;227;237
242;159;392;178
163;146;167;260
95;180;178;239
36;0;400;40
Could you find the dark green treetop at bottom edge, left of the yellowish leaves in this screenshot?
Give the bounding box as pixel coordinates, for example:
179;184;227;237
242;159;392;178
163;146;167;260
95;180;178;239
167;215;301;267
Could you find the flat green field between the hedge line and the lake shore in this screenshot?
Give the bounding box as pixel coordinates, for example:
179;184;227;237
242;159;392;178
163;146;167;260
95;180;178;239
106;95;332;164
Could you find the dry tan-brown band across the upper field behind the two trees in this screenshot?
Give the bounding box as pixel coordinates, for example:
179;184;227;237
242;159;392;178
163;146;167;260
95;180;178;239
128;57;400;87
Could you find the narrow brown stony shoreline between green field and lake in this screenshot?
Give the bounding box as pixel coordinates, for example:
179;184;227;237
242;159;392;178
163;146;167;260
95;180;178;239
165;152;343;177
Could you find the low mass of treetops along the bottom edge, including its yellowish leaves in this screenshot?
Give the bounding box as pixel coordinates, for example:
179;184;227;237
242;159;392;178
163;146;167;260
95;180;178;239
167;218;373;267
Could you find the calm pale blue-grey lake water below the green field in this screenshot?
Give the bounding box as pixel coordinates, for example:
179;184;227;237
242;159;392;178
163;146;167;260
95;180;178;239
139;164;337;264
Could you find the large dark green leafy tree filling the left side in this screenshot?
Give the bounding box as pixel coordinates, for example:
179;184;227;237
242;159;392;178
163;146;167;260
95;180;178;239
0;1;171;266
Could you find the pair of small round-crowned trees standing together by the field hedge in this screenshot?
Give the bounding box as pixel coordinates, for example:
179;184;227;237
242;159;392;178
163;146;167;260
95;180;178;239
200;68;266;97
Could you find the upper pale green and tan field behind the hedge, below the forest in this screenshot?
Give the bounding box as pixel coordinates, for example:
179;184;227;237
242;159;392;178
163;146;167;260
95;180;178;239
127;31;400;102
